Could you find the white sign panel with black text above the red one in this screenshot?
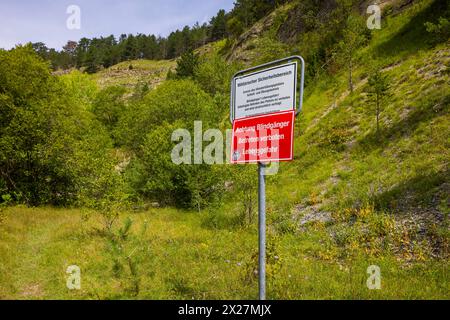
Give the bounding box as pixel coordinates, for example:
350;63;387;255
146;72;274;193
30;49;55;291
233;62;297;120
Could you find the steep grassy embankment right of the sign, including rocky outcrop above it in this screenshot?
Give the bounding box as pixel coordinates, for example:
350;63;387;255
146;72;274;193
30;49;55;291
222;1;450;261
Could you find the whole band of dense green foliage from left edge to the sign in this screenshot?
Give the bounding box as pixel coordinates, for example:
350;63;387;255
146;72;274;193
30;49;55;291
0;46;244;210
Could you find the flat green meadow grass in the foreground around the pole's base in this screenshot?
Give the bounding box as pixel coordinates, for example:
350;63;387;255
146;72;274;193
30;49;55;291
0;207;449;299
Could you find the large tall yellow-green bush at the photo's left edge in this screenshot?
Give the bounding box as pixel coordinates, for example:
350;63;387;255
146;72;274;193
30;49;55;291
0;46;121;205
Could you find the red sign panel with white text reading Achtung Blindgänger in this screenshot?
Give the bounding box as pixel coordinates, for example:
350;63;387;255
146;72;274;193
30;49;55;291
231;111;295;163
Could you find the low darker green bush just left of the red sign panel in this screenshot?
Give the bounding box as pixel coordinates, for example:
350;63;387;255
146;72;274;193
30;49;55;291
127;122;223;210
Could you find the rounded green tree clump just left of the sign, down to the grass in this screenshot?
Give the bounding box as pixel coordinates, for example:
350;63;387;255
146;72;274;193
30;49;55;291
119;80;223;210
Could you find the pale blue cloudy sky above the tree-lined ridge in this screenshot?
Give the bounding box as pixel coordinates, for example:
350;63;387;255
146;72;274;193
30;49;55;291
0;0;234;50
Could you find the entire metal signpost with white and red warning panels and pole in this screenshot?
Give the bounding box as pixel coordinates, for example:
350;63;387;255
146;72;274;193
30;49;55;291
230;56;305;300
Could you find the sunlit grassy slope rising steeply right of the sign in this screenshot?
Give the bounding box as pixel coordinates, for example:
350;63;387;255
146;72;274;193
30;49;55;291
276;1;450;220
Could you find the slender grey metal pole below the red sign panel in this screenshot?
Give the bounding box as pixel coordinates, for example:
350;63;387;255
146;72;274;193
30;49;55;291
258;163;266;300
